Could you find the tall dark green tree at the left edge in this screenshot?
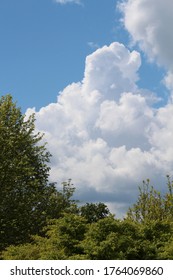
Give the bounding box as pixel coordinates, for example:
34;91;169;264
0;95;56;249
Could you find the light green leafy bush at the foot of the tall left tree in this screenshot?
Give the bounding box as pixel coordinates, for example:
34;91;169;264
2;213;87;260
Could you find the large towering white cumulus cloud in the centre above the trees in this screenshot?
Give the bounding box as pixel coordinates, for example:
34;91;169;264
26;42;173;215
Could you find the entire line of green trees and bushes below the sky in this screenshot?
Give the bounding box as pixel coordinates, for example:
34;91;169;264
0;95;173;260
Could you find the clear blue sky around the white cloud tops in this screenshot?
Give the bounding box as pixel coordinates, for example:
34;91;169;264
0;0;165;111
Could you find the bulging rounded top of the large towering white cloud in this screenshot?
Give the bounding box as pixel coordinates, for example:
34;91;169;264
83;43;141;100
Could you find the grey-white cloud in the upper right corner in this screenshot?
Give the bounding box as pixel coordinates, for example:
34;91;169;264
120;0;173;96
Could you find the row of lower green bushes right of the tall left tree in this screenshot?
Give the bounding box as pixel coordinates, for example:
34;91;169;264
2;177;173;260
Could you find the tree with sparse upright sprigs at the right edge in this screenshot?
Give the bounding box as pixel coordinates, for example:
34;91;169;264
126;176;173;259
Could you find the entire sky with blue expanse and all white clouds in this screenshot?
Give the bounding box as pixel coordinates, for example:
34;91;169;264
0;0;173;217
